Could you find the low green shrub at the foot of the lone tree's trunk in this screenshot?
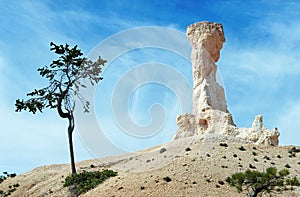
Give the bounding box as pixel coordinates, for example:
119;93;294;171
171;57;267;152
64;169;118;195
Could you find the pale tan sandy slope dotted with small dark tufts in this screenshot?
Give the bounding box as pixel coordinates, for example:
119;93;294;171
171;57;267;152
0;137;300;196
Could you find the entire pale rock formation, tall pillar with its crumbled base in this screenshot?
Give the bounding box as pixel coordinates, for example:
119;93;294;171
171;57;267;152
174;22;279;145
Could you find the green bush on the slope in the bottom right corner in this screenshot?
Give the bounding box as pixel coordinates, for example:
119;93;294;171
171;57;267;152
225;167;300;197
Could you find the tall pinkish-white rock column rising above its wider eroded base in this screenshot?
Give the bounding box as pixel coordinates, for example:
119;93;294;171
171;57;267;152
186;22;228;117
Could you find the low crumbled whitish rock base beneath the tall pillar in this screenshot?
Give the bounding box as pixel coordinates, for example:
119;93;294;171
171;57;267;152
174;110;280;146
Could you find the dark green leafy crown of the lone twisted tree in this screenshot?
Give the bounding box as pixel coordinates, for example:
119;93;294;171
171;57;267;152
15;42;106;114
